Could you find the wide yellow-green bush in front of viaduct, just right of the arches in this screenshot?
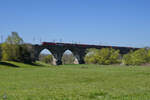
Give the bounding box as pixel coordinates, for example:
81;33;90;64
84;48;120;65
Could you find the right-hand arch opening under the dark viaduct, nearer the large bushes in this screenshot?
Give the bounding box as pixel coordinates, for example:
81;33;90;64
62;50;79;64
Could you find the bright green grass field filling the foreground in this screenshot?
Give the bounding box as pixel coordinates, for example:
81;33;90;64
0;62;150;100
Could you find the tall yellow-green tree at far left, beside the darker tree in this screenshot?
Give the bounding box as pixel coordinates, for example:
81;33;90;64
2;32;23;61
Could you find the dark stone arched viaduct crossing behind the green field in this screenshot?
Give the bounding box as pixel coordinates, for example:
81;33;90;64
32;42;138;65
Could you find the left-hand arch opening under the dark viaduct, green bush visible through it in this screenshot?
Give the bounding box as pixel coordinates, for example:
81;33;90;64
39;48;56;65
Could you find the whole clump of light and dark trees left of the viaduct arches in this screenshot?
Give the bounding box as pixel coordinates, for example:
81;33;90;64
2;32;32;63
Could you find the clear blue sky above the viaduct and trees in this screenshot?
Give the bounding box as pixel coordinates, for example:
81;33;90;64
0;0;150;47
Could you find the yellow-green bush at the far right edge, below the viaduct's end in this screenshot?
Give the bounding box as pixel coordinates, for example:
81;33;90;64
122;48;150;65
